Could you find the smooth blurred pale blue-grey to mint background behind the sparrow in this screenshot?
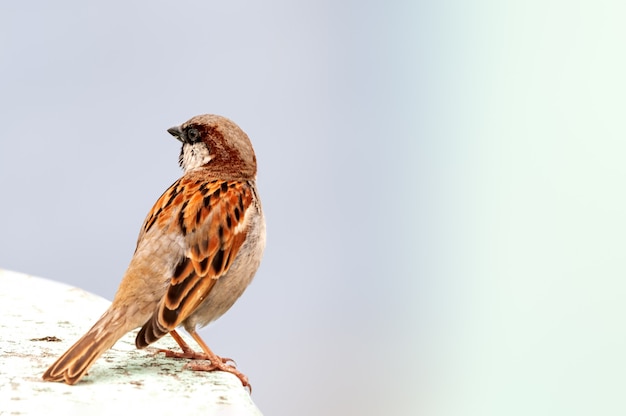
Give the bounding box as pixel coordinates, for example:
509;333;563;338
0;0;626;416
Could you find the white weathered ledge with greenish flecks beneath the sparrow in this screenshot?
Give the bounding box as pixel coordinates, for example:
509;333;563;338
0;270;261;416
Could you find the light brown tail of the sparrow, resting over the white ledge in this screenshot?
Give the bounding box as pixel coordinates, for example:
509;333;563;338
43;311;130;384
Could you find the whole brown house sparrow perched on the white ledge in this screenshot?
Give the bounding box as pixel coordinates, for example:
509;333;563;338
43;115;265;386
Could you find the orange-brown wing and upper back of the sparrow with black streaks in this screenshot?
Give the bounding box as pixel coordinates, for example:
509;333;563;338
136;177;254;348
